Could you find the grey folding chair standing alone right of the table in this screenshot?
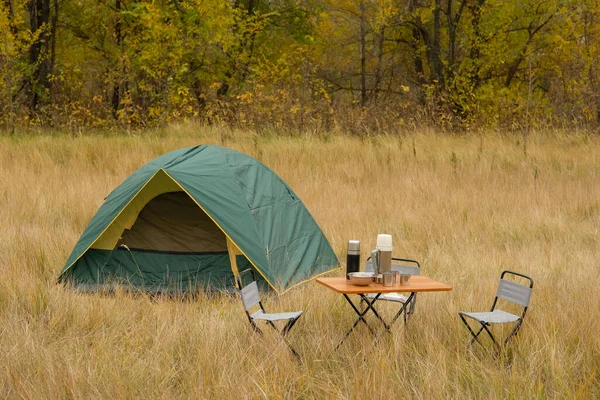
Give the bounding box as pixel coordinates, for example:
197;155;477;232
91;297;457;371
458;271;533;351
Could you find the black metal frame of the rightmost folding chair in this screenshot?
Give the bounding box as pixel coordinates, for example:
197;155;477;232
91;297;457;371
458;270;533;351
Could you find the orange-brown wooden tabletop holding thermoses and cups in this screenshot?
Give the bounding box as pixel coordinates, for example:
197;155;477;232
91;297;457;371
317;275;452;294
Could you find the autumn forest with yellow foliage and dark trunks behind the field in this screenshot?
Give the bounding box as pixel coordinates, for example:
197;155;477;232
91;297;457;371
0;0;600;135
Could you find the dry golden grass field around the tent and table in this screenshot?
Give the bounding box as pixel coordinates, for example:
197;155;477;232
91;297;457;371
0;126;600;399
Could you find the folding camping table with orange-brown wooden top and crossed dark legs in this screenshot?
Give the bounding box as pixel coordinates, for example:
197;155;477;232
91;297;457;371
317;275;452;349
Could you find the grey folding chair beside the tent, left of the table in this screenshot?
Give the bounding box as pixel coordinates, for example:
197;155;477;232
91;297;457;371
236;269;302;358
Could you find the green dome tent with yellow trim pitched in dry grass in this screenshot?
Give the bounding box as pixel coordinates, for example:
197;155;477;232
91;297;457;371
59;146;339;293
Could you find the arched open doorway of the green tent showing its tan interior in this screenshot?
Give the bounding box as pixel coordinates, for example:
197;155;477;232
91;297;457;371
88;191;251;290
